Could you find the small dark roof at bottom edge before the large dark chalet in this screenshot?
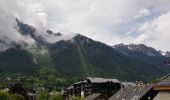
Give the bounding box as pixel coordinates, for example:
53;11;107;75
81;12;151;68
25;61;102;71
84;93;108;100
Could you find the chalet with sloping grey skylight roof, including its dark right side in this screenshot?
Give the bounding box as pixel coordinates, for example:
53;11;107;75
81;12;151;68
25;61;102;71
109;85;158;100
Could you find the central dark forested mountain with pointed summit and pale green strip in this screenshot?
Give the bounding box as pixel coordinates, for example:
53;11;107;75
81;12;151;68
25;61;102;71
50;34;164;80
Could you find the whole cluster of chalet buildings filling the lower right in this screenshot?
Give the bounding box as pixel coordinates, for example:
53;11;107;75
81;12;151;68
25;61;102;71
63;75;170;100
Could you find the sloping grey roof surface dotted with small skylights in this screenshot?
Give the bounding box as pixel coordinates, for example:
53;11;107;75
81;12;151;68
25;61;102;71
109;86;153;100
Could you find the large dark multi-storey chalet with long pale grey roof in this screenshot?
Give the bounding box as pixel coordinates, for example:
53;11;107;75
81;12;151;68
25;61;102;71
63;77;121;97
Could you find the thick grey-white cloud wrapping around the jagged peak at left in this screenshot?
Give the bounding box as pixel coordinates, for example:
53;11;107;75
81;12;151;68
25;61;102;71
0;0;46;51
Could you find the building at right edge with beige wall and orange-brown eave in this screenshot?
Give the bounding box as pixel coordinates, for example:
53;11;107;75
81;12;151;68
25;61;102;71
154;75;170;100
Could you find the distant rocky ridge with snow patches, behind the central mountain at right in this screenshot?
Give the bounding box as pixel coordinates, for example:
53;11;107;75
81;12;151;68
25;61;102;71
113;44;170;73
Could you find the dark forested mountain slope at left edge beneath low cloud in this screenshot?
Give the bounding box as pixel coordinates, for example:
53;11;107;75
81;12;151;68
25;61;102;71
0;49;37;74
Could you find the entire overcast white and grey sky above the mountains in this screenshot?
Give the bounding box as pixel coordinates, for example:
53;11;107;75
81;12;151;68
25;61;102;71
0;0;170;51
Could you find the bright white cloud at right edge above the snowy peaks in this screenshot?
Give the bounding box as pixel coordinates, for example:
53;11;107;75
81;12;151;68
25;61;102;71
136;12;170;50
